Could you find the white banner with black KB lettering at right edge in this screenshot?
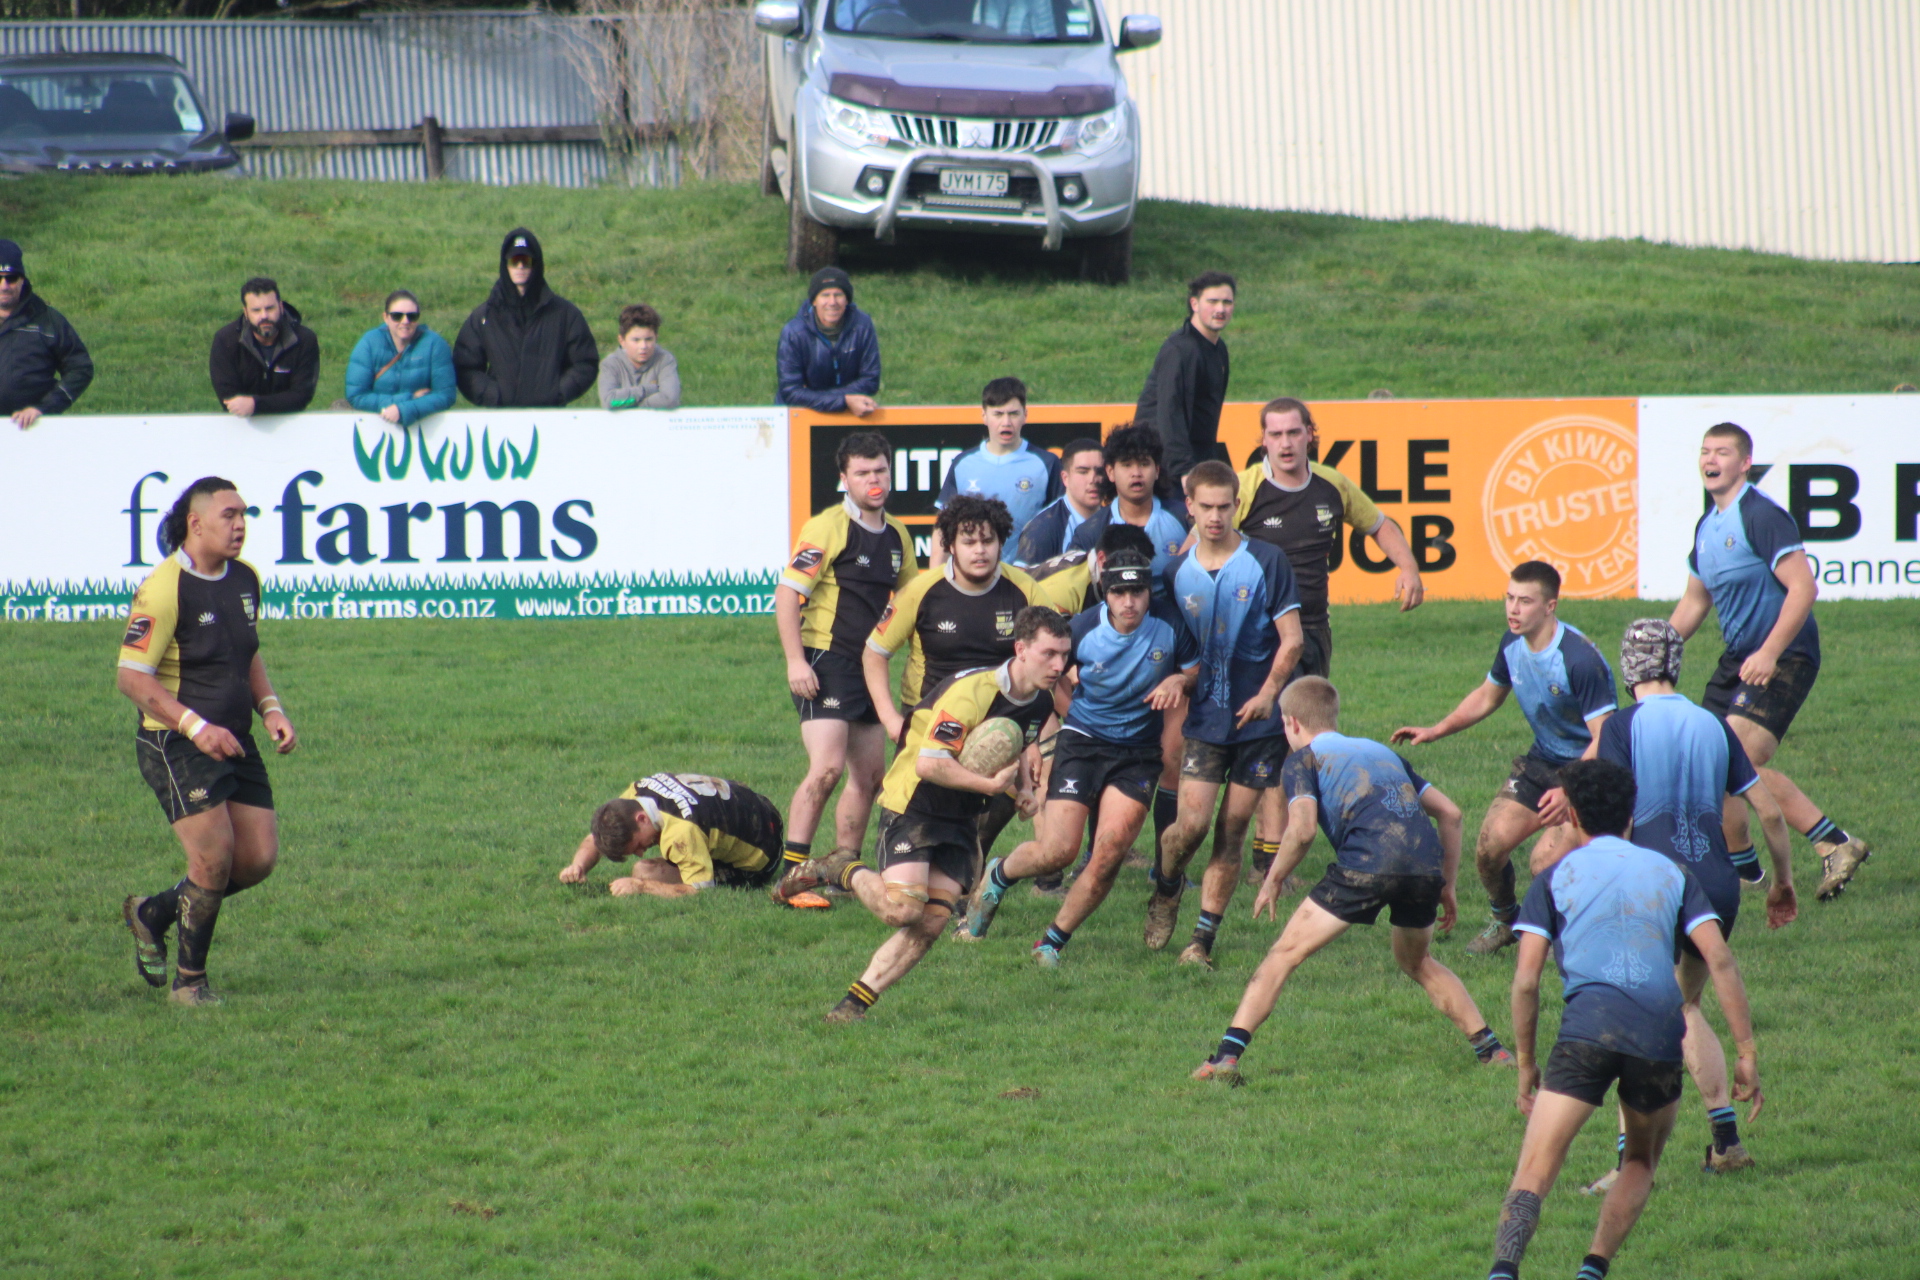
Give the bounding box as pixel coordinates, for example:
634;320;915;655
1640;395;1920;601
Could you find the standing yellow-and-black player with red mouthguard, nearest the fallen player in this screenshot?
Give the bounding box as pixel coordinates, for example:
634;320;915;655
774;432;920;890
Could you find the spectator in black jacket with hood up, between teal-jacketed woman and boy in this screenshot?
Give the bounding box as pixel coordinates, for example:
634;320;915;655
453;226;599;409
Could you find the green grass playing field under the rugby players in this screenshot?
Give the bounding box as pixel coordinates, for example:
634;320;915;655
0;602;1920;1280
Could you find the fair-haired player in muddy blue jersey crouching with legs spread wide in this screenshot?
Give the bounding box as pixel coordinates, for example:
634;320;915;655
1194;676;1513;1084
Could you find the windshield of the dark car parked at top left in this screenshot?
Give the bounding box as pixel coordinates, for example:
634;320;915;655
0;71;207;138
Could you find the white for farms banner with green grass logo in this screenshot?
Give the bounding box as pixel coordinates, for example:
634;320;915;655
0;409;787;622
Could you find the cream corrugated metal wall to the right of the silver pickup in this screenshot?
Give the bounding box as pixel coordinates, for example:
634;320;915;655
1108;0;1920;261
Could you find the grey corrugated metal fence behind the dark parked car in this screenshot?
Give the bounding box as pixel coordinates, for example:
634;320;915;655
0;13;656;186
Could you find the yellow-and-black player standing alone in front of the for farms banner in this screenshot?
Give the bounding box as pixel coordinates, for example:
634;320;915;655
117;476;300;1006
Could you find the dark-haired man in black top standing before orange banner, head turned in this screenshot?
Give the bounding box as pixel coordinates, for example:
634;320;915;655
1133;271;1236;482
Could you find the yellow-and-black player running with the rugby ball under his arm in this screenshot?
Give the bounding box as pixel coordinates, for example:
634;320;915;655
783;604;1073;1023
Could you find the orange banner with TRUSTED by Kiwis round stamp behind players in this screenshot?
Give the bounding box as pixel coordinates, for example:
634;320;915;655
789;397;1640;604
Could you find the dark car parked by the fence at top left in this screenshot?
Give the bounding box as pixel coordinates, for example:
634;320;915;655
0;54;253;173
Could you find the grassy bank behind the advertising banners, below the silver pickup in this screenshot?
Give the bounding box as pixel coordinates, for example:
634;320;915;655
0;177;1920;413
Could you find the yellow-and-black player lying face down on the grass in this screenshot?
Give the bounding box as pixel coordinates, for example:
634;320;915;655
561;773;781;898
